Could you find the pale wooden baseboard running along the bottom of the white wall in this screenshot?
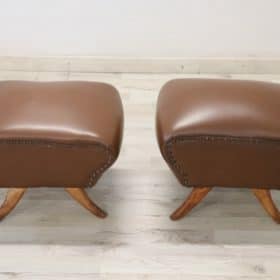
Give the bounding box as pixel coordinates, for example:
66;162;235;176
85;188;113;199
0;56;280;74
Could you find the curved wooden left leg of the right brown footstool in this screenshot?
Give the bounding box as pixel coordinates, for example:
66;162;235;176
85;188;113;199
170;187;212;221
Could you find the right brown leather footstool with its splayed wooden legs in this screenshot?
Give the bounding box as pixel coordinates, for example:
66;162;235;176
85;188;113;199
157;79;280;223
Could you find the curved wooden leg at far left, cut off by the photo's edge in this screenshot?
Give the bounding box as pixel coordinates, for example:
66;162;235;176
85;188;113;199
0;188;27;220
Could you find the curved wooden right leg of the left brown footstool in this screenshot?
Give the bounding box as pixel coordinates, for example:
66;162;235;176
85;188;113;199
65;188;107;218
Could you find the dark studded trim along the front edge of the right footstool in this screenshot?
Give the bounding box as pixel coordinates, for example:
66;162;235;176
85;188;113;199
164;135;280;185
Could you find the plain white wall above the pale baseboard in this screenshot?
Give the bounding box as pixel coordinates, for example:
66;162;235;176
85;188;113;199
0;0;280;57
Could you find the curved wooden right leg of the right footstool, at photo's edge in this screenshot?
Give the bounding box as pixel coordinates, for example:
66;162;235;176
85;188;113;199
253;189;280;224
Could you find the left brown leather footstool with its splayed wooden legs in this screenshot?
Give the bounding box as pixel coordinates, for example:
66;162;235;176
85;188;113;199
0;81;123;219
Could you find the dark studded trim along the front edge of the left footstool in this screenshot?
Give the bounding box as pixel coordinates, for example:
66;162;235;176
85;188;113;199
0;139;113;188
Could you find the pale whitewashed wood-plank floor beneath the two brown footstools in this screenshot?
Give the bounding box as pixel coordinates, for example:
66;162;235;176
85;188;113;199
0;71;280;280
